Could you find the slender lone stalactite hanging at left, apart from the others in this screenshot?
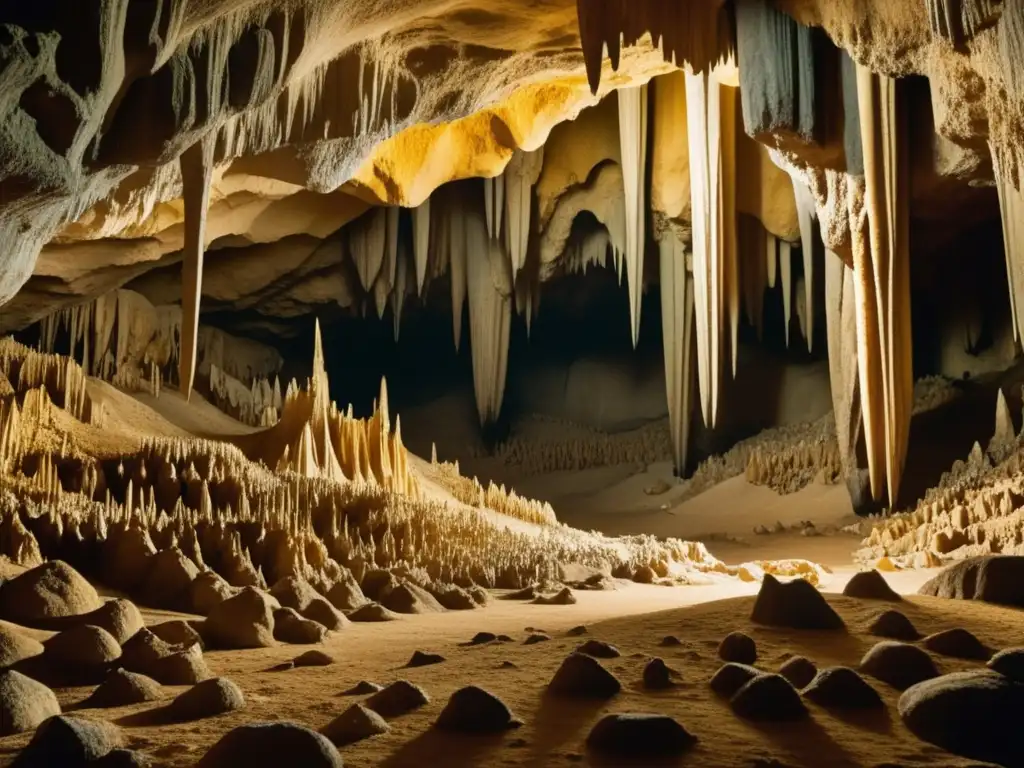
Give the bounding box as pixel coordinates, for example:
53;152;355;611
178;134;216;399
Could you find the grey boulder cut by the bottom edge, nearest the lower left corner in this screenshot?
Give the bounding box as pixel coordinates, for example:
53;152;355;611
12;715;124;768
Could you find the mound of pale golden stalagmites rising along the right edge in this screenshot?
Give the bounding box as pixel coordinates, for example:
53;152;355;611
857;391;1024;568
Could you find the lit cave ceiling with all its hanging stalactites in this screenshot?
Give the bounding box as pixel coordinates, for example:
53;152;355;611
0;0;1024;512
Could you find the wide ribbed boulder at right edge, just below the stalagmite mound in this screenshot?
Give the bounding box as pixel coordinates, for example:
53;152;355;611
918;555;1024;608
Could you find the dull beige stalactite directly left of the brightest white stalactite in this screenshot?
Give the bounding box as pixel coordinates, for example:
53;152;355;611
658;228;693;477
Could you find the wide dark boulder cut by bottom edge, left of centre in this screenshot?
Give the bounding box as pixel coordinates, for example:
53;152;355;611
196;722;343;768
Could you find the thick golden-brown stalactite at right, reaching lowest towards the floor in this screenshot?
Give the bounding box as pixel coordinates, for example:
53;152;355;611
854;65;913;505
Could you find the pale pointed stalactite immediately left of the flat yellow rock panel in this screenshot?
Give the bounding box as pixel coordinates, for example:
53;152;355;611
617;85;647;347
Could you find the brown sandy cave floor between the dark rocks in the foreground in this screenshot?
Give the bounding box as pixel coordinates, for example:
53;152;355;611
0;571;1024;768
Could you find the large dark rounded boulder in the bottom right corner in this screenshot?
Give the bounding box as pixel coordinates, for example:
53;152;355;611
899;670;1024;766
